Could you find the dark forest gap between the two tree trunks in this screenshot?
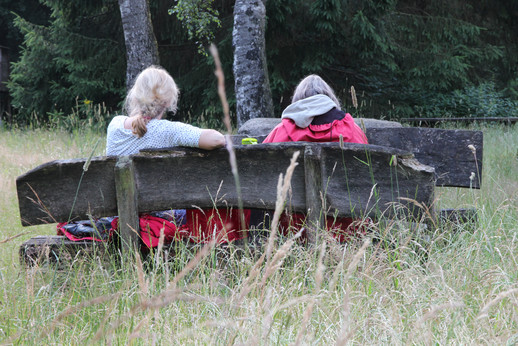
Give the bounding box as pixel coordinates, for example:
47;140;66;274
160;3;237;129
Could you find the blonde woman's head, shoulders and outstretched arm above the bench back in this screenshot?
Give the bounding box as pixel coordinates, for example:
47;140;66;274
106;66;225;155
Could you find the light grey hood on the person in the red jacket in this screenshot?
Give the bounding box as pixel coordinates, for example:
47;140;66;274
281;95;338;128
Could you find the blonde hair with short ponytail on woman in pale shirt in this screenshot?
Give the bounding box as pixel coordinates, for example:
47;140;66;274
125;66;179;137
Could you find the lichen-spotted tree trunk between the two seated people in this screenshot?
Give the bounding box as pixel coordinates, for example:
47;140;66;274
232;0;273;126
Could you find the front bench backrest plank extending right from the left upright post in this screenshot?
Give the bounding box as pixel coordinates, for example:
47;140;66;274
138;142;435;216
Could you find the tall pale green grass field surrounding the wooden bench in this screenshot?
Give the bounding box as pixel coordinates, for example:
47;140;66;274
0;126;518;345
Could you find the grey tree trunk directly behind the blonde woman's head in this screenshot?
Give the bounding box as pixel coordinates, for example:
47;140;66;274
119;0;159;89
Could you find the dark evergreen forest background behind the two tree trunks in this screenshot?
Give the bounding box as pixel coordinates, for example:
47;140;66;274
0;0;518;127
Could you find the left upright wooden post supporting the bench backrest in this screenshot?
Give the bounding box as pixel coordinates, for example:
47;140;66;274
115;156;140;251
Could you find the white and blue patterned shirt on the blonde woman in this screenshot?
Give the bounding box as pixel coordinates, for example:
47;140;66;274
106;115;202;155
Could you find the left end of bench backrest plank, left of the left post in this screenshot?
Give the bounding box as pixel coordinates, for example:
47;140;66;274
16;157;117;226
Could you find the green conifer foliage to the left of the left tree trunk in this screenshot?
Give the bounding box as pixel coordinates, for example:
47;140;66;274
8;1;125;123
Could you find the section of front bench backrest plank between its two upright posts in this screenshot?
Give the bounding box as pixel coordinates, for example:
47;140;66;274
133;144;305;211
